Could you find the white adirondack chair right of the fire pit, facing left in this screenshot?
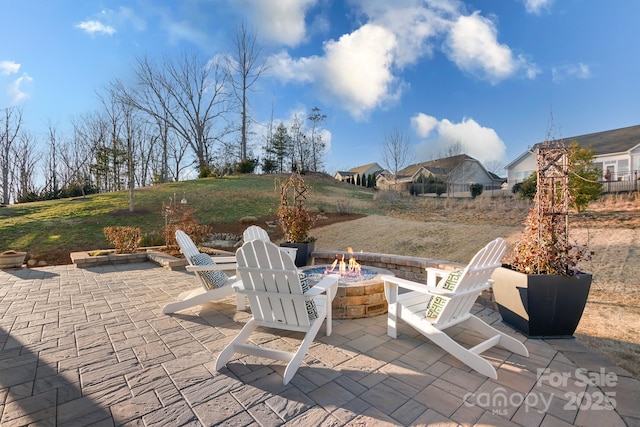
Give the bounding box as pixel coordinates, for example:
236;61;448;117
382;238;529;379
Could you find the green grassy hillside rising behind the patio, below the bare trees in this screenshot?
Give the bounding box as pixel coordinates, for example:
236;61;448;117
0;175;374;256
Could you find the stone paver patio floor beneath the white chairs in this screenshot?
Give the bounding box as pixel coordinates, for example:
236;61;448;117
0;262;640;426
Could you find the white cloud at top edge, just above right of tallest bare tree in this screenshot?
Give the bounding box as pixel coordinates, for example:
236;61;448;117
236;0;317;46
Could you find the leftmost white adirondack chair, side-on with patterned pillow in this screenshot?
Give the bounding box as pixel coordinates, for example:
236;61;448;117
162;230;245;314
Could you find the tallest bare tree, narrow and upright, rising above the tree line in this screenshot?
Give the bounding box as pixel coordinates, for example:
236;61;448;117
227;22;266;160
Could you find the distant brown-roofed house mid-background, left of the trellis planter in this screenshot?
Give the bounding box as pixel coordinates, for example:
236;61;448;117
376;154;504;195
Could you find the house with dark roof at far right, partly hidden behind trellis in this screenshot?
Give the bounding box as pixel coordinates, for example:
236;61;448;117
505;125;640;188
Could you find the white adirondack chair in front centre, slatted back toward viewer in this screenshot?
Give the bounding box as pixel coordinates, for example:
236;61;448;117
216;240;338;384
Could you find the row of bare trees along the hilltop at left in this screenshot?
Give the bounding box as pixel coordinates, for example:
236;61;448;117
0;24;326;210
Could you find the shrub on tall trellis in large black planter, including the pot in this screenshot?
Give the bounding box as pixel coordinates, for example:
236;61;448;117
492;140;592;337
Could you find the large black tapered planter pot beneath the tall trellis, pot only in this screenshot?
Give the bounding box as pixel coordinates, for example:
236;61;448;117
491;267;592;338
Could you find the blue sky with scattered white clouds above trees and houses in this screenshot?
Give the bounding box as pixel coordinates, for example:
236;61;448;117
0;0;640;174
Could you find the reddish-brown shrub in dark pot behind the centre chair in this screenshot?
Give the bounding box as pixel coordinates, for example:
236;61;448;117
278;172;315;267
